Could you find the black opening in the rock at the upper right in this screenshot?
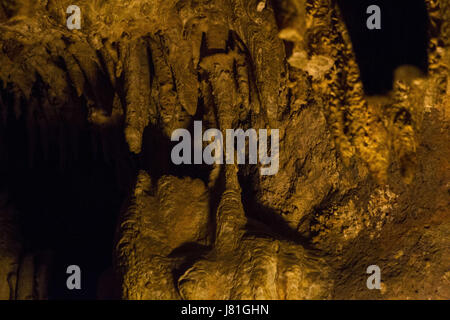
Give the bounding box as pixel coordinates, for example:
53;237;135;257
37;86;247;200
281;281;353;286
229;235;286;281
337;0;429;95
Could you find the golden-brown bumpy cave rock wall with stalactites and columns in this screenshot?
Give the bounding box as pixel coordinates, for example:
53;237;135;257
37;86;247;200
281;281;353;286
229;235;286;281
0;0;450;299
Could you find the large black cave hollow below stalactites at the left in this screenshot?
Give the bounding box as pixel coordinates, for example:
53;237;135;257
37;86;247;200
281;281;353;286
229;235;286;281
0;104;133;300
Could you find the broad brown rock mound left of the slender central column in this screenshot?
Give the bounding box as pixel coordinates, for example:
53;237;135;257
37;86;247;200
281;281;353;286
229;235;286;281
115;171;208;299
